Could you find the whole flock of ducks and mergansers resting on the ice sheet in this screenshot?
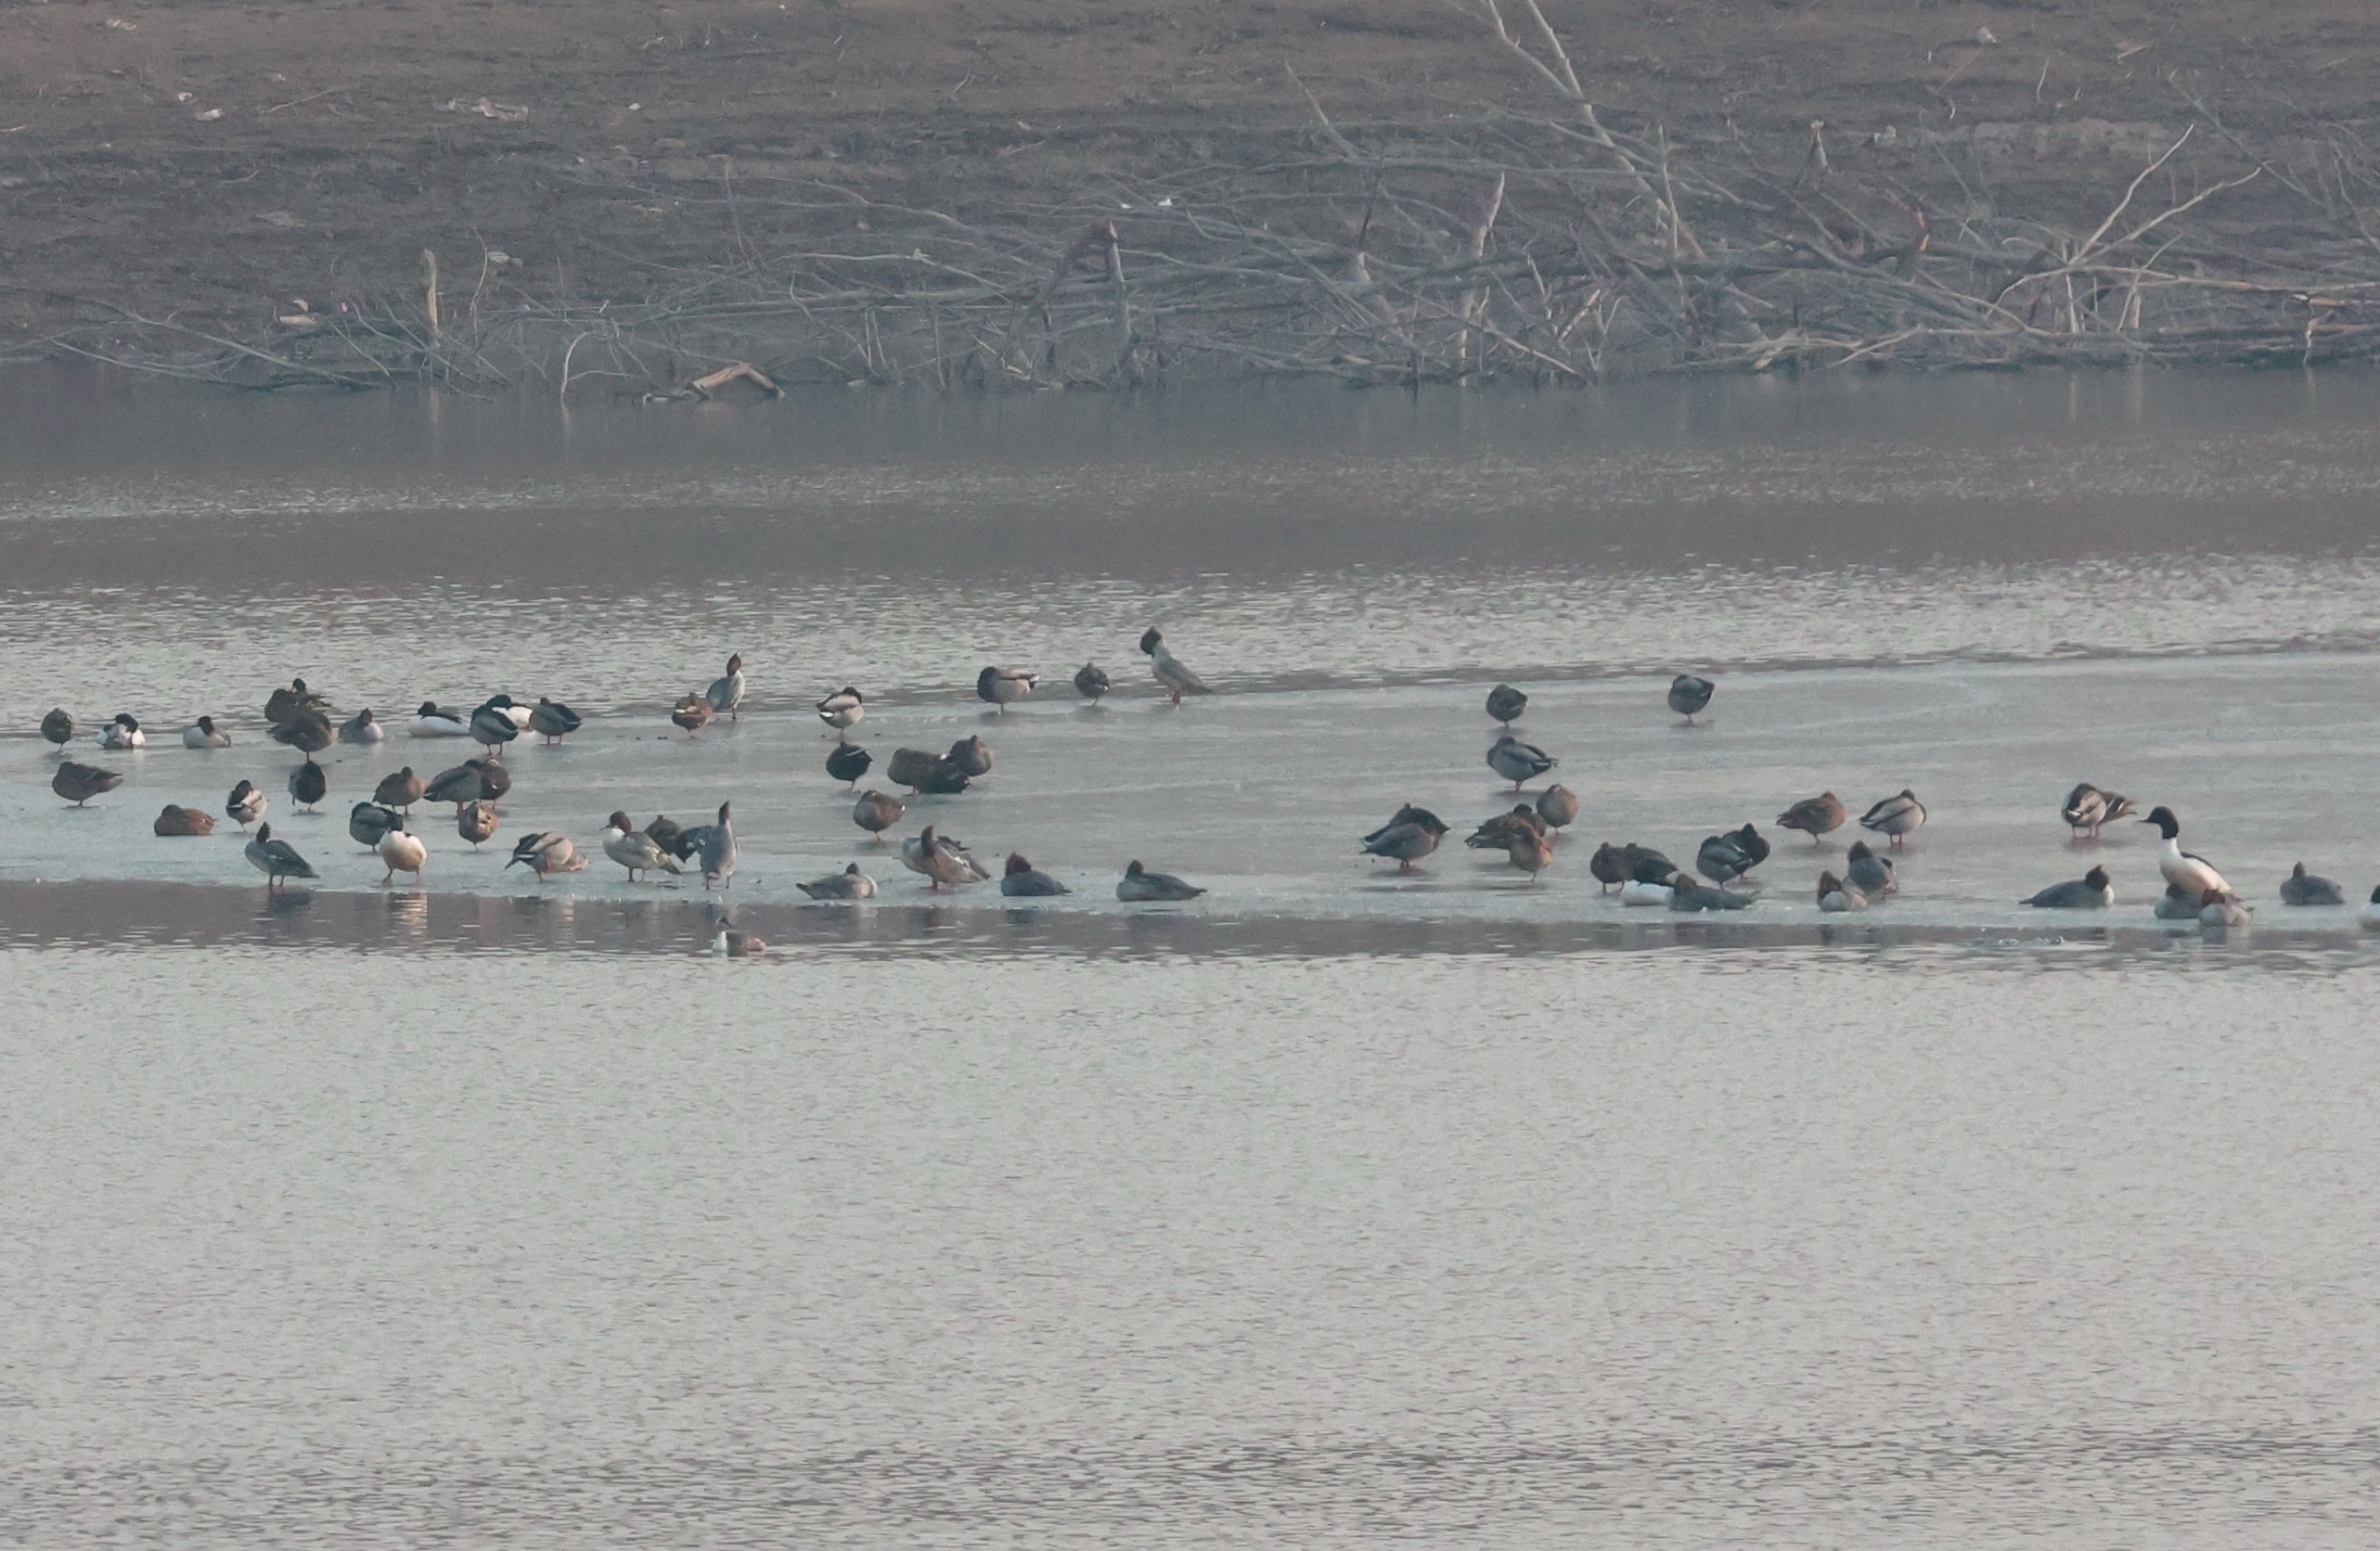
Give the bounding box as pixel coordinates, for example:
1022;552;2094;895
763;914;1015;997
41;628;2380;952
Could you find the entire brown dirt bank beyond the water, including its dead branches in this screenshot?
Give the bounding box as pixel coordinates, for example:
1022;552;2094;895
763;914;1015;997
0;0;2380;391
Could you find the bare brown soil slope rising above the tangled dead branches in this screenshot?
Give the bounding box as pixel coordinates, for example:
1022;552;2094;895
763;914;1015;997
0;0;2380;347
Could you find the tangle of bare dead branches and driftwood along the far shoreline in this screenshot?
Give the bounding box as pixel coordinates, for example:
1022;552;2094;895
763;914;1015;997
42;0;2380;397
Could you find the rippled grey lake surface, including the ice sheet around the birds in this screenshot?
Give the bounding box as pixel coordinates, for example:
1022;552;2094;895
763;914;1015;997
0;371;2380;1548
